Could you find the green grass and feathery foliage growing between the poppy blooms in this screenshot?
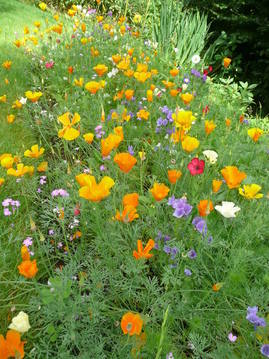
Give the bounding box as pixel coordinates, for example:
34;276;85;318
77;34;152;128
0;0;269;359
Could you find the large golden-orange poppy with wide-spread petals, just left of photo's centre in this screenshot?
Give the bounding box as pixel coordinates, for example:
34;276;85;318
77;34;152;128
76;173;115;202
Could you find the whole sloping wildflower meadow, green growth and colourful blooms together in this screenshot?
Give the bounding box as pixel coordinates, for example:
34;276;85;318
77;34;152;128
0;0;269;359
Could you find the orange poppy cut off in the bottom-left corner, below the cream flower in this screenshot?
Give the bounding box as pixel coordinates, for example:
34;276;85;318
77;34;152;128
0;330;26;359
